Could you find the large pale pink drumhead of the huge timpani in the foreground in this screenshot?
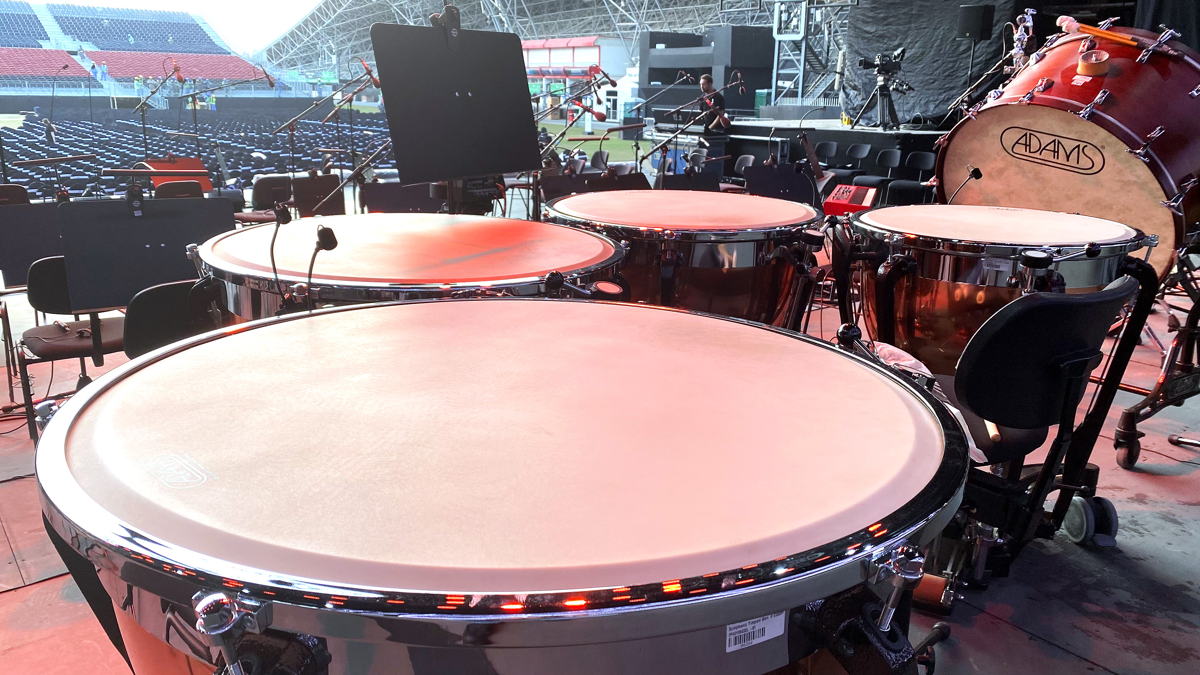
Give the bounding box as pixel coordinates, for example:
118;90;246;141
38;299;946;592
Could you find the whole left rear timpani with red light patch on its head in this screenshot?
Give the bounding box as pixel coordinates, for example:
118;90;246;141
197;214;624;318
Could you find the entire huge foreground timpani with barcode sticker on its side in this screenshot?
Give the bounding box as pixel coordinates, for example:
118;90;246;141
36;298;967;675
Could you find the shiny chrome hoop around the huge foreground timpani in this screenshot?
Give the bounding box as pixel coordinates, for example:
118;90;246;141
35;298;968;620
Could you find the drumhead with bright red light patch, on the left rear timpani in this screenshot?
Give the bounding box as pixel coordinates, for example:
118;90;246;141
200;214;616;286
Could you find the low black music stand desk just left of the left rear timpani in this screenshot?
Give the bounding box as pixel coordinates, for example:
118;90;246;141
59;198;234;313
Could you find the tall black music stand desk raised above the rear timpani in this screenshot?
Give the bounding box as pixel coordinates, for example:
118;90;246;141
371;24;541;184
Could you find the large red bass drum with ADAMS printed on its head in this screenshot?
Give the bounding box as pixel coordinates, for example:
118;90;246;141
937;28;1200;275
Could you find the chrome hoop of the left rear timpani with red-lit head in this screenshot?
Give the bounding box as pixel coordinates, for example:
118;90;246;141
197;222;625;290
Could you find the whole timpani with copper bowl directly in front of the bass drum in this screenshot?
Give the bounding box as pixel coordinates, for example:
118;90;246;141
850;204;1147;375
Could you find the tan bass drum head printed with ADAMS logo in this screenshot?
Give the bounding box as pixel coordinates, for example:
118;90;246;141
940;104;1176;273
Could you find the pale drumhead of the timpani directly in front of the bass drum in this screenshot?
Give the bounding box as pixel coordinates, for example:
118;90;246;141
859;204;1138;246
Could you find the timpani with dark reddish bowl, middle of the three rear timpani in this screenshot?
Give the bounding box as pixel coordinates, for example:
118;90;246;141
547;190;820;328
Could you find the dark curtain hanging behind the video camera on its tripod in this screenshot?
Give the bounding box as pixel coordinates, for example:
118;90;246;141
840;0;1024;124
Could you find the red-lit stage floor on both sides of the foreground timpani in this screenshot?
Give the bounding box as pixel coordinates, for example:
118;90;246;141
0;297;1200;675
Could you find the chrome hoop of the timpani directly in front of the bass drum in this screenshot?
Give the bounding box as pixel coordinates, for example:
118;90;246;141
850;211;1147;259
